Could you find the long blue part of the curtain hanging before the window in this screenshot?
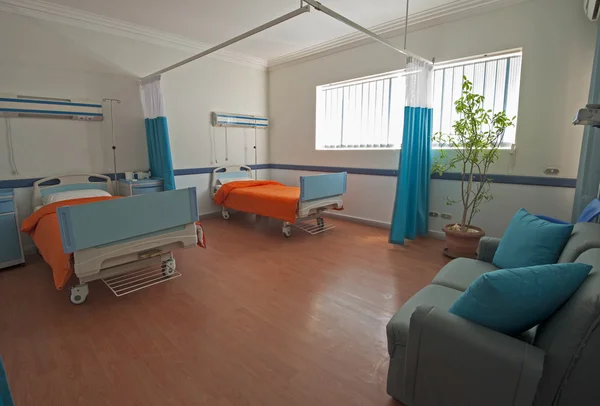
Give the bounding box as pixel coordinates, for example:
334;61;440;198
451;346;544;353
390;106;433;245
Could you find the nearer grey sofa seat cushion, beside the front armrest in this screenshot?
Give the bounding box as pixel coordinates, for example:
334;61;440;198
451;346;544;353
386;285;463;357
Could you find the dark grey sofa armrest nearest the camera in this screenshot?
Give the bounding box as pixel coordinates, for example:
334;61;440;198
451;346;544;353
405;306;545;406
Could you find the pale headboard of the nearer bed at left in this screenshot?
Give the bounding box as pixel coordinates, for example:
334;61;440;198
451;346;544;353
32;173;113;208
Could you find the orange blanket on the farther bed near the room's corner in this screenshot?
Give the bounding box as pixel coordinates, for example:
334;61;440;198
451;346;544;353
214;180;300;223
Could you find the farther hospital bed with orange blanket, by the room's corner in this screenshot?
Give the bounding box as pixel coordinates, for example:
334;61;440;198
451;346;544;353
211;166;347;237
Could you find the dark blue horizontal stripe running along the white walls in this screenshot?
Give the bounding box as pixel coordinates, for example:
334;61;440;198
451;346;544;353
0;164;577;189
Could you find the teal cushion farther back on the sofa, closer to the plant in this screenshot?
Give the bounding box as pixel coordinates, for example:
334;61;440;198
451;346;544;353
492;209;573;269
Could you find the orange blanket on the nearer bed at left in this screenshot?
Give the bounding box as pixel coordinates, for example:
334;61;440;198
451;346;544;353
21;196;119;289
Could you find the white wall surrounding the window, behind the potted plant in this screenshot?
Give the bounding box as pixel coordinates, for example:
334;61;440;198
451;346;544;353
269;0;596;235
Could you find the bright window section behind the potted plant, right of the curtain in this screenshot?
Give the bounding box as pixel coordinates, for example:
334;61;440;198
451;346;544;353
433;52;522;148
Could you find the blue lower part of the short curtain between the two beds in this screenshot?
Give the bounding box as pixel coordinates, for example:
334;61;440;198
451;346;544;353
145;117;175;190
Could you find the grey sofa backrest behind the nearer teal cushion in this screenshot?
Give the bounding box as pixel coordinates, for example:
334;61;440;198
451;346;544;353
534;246;600;406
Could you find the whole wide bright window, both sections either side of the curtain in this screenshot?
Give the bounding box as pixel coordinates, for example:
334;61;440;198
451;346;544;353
316;52;522;149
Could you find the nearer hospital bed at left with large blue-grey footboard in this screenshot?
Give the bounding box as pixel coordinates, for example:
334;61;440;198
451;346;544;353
24;174;198;304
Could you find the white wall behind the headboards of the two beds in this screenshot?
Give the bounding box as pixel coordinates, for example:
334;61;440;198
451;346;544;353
0;12;268;251
